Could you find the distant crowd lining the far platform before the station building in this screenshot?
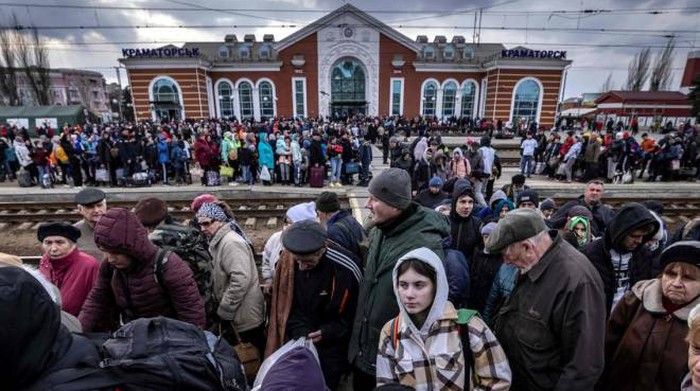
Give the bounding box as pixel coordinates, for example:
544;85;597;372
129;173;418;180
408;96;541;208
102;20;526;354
0;116;700;191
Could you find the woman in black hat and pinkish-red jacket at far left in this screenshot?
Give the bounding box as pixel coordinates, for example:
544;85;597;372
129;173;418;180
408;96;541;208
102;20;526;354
37;223;100;316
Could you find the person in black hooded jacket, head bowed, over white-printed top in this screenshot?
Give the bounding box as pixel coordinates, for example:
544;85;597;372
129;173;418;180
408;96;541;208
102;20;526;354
582;202;659;314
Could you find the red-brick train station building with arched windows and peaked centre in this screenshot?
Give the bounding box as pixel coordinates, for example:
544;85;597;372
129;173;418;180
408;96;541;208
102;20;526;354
119;4;571;126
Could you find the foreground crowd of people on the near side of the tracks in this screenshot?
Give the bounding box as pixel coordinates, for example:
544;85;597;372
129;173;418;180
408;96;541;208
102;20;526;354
0;161;700;391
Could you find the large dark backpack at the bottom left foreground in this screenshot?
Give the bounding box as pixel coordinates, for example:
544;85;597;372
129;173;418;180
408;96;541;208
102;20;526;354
100;316;248;391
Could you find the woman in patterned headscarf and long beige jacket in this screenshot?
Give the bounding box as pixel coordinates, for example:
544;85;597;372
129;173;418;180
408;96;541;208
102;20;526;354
197;203;265;351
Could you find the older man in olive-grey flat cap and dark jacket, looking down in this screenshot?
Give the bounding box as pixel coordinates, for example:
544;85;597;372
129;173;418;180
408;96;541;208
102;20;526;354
485;208;606;390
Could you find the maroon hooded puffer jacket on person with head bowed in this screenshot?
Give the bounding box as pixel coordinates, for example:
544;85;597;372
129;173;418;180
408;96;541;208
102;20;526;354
79;208;206;332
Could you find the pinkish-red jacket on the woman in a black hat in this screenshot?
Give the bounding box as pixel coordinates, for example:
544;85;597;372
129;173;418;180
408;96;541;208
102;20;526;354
39;247;100;316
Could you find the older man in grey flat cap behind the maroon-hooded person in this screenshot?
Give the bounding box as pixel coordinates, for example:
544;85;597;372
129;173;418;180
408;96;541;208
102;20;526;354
73;187;107;261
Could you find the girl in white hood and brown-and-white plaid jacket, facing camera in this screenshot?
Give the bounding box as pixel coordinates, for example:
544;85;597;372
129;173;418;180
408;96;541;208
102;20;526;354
377;248;511;391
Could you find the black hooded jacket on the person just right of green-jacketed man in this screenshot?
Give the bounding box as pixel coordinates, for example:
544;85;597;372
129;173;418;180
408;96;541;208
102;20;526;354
450;179;483;259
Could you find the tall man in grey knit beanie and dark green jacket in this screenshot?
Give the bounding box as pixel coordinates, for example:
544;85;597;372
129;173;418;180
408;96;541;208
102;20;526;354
348;168;450;390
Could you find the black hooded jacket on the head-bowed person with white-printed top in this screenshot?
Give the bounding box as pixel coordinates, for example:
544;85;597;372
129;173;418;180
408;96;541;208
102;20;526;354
581;202;659;314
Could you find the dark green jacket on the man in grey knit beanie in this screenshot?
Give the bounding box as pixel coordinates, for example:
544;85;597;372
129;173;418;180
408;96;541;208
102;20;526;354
348;202;450;375
